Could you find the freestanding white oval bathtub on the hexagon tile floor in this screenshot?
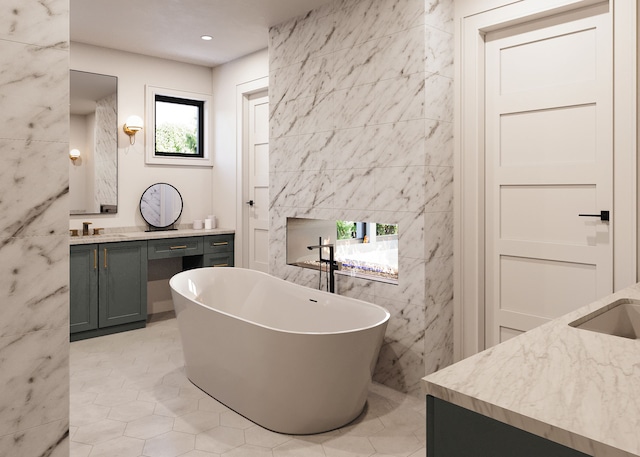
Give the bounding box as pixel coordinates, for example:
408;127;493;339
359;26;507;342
169;268;389;434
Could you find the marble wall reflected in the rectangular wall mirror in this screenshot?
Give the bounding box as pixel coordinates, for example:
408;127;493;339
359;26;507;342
93;93;118;212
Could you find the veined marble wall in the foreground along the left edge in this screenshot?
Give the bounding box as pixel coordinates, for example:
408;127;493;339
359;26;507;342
0;0;69;457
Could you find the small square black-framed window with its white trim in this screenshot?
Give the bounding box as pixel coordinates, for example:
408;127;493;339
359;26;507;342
145;86;213;167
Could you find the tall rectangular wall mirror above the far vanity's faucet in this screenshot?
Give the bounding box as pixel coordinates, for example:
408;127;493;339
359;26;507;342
69;70;118;215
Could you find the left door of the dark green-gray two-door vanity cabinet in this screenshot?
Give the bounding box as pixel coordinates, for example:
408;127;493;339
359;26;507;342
69;244;98;333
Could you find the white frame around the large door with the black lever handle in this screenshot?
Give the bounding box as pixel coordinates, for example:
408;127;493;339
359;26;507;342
453;0;638;361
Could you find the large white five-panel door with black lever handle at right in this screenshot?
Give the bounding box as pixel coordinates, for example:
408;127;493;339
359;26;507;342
485;4;615;347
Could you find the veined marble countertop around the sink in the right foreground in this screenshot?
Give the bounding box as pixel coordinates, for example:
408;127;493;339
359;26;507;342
422;284;640;457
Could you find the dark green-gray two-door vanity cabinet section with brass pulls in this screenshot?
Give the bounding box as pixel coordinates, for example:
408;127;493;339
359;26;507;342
70;241;147;341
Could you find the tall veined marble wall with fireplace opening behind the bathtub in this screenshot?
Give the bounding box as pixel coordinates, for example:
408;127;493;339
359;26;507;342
269;0;453;394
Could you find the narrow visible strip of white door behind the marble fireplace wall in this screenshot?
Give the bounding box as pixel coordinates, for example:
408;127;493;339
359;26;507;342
243;91;269;273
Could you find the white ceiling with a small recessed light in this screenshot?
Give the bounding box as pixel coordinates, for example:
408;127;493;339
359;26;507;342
70;0;330;67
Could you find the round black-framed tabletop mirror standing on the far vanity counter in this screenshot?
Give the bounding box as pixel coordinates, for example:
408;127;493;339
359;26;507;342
140;183;182;231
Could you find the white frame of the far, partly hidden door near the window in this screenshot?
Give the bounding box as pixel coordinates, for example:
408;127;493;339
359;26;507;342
234;76;269;268
